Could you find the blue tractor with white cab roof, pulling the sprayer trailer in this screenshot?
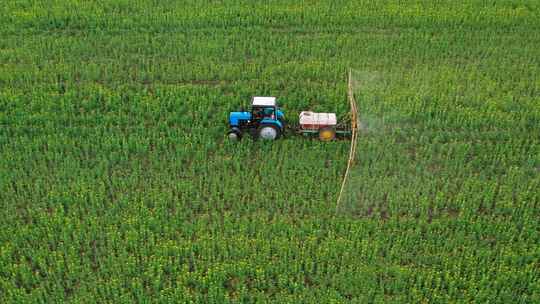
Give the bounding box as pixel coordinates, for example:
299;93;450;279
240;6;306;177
228;97;285;140
